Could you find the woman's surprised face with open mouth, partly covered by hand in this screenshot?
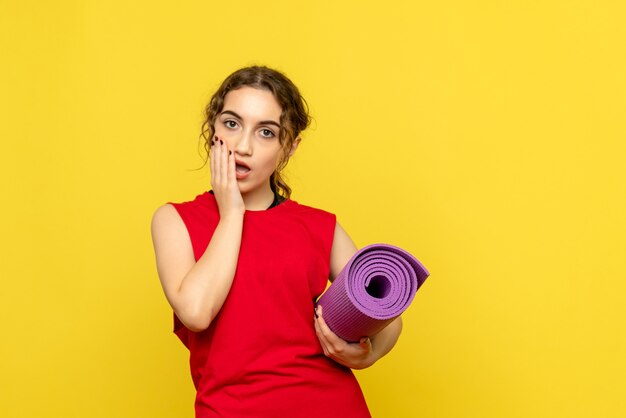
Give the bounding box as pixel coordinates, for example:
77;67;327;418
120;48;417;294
215;86;282;194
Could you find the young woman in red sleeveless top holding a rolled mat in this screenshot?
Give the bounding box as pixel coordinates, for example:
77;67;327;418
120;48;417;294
152;66;402;418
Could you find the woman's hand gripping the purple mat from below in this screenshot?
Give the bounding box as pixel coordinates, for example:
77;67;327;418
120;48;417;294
314;305;377;369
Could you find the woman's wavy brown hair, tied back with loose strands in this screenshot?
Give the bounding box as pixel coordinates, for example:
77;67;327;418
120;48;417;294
200;65;311;198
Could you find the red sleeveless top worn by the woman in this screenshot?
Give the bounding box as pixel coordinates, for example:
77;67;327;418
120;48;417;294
168;192;371;418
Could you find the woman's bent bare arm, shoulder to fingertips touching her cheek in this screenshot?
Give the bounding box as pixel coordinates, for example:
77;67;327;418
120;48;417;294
152;137;245;331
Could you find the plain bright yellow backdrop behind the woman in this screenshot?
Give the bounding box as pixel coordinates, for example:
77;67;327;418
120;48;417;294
0;0;626;418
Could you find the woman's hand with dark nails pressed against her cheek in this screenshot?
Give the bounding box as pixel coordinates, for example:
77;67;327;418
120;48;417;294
210;135;246;218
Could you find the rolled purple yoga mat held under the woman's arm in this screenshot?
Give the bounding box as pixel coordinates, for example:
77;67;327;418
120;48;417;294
317;244;430;342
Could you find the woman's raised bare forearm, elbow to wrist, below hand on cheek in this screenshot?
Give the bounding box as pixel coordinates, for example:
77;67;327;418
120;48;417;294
175;216;243;331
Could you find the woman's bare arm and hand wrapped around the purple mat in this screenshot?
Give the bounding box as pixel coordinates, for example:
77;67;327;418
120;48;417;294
315;223;402;369
